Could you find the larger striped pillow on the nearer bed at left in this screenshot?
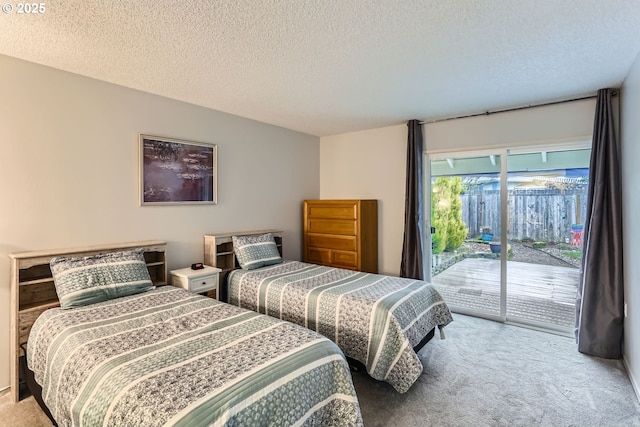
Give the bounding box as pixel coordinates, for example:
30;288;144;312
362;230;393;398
49;249;155;308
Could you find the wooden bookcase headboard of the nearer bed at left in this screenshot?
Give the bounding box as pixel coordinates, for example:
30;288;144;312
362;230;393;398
9;240;167;402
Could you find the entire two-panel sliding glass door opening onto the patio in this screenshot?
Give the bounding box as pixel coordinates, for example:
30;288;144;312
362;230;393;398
425;143;590;334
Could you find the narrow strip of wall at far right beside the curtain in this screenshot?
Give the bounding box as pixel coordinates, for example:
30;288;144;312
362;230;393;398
620;51;640;398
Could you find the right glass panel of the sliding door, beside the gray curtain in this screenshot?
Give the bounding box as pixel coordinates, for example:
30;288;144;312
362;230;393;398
506;148;591;334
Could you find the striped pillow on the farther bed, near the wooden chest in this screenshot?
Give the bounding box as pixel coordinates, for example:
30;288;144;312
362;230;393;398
231;233;283;270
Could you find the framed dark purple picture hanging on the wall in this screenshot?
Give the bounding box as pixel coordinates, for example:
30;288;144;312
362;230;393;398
140;134;218;205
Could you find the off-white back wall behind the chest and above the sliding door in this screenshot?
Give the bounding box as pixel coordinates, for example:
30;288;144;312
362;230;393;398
320;99;595;275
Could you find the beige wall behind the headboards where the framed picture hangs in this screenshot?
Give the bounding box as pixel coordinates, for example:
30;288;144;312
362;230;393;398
0;56;320;389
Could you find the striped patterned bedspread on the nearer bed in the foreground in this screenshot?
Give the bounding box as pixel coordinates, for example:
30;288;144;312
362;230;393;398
27;286;362;427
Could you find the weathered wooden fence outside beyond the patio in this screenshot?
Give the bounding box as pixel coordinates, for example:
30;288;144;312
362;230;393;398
461;186;587;243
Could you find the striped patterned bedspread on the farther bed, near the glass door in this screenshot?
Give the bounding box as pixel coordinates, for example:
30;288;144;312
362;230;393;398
228;261;453;393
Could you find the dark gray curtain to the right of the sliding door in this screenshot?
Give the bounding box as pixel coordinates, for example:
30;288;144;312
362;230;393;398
576;89;624;359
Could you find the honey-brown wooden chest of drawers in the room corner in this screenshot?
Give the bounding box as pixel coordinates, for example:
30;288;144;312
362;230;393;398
303;200;378;273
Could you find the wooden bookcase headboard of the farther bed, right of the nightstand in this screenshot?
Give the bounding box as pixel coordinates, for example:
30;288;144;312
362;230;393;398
204;230;282;301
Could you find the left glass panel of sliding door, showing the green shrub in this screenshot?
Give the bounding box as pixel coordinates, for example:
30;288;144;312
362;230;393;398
429;152;505;319
